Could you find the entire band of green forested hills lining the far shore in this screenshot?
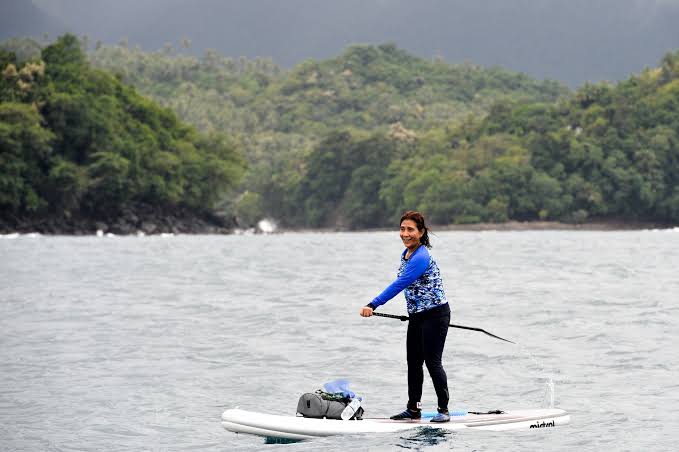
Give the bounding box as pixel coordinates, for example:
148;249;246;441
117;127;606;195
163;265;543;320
0;35;679;235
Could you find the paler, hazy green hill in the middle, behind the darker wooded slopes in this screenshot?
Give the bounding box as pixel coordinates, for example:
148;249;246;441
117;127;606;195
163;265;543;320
91;43;568;227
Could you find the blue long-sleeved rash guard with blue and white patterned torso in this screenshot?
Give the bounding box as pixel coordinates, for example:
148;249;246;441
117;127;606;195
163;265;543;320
368;246;448;314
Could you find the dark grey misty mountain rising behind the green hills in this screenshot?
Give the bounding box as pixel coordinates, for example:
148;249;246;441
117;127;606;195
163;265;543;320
14;0;679;86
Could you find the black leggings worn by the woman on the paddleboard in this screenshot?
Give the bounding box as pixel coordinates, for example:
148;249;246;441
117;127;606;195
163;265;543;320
406;303;450;410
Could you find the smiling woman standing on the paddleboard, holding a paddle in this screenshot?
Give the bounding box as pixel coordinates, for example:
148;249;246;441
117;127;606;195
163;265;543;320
361;211;450;422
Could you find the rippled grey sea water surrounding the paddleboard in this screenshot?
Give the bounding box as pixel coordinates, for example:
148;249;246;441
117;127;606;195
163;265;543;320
0;230;679;451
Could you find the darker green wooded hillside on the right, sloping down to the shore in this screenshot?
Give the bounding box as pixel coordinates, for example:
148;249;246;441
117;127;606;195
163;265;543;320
293;51;679;227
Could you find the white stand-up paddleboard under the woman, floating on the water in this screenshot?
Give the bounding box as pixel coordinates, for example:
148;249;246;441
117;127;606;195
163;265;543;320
222;408;570;440
